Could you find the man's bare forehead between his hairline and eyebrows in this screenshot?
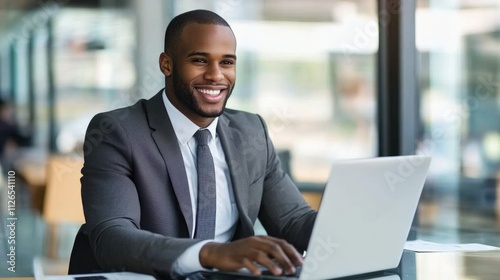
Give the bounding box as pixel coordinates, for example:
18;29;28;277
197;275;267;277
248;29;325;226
177;23;236;54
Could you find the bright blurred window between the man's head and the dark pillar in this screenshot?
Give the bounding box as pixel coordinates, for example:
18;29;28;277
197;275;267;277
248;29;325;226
174;0;378;186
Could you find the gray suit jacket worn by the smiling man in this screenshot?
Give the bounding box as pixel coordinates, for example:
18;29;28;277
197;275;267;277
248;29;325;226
72;90;316;276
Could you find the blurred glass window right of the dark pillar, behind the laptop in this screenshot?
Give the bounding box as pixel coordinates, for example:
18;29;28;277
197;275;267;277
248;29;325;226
416;0;500;245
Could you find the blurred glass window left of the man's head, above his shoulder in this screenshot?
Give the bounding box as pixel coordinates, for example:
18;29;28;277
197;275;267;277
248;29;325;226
54;7;135;152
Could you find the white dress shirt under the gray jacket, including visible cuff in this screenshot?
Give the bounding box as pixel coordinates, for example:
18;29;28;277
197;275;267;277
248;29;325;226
162;91;238;275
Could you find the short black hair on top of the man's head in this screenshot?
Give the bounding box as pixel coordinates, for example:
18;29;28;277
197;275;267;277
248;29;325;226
164;10;231;52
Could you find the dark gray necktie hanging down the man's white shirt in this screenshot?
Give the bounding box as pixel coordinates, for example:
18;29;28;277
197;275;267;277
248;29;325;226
194;129;216;239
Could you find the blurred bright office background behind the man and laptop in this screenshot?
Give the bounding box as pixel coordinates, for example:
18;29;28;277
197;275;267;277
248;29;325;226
0;0;500;276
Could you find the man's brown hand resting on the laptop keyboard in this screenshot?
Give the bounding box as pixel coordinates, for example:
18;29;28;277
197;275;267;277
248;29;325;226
200;236;303;275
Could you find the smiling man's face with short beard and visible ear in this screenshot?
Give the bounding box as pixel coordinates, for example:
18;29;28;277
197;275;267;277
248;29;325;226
160;23;236;126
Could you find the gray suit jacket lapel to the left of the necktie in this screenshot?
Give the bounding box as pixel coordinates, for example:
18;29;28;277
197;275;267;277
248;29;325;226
146;90;193;236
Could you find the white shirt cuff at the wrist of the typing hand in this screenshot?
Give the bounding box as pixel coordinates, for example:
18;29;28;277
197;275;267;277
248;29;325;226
172;240;214;277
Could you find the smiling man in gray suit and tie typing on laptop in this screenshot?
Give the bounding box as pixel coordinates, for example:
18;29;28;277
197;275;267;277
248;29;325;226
70;10;316;278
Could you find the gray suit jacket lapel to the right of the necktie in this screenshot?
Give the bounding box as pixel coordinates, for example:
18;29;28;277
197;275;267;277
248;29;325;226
217;114;253;234
